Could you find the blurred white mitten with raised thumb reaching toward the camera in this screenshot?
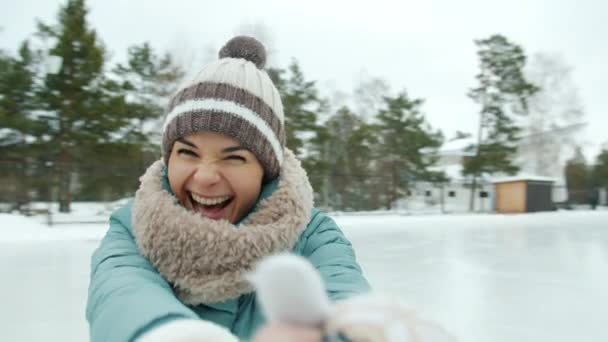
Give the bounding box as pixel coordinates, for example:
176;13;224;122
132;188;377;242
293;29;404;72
248;254;455;342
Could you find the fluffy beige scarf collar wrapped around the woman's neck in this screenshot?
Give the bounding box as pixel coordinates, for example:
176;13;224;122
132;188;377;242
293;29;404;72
132;149;313;305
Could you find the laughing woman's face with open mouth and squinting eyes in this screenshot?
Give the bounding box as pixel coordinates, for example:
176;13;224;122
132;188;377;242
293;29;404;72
168;132;264;223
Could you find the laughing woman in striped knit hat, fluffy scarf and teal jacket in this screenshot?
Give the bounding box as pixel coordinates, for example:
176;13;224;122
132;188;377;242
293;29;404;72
87;37;368;341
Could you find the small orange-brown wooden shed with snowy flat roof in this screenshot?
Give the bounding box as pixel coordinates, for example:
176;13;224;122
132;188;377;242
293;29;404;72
493;177;555;213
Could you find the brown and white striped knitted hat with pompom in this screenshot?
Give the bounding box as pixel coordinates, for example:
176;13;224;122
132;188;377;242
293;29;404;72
162;36;285;180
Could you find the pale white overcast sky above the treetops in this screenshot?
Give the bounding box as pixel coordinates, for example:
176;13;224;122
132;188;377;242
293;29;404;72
0;0;608;160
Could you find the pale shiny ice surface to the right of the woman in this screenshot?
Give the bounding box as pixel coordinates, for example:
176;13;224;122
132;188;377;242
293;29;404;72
338;211;608;342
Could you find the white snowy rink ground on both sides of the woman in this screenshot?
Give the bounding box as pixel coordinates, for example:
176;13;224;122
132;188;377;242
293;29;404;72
0;210;608;342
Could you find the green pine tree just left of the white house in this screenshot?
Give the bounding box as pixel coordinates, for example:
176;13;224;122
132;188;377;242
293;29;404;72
376;91;443;209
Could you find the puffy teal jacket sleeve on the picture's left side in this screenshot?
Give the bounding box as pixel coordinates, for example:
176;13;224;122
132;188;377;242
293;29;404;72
86;205;198;342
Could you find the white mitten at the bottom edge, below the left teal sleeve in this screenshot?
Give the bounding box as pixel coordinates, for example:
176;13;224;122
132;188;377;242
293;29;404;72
137;319;239;342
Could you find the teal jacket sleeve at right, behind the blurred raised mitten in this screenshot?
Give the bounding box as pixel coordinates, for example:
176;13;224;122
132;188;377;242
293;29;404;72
302;209;370;300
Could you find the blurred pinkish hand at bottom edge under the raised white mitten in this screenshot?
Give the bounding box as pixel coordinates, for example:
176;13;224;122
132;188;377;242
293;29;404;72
253;323;322;342
